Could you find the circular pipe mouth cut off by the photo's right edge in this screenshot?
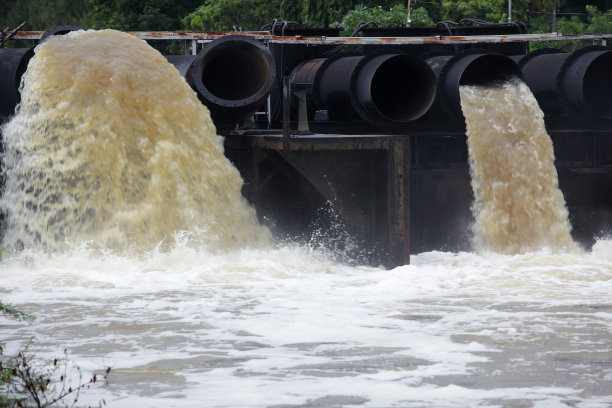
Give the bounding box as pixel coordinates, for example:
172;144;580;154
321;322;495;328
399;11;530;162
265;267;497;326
563;50;612;120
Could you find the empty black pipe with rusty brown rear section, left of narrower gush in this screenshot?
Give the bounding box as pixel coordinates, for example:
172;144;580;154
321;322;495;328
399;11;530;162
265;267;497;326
291;54;436;127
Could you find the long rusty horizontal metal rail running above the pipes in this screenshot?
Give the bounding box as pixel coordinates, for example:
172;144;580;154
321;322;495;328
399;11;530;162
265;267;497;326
14;31;612;45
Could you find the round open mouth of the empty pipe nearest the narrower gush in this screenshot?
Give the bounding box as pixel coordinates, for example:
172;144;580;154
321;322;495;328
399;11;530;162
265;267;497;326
356;54;436;125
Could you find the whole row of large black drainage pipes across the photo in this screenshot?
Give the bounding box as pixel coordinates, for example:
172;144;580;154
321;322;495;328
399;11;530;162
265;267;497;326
0;28;612;128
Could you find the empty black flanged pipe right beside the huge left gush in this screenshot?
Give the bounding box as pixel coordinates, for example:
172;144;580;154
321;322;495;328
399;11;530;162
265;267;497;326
184;35;275;126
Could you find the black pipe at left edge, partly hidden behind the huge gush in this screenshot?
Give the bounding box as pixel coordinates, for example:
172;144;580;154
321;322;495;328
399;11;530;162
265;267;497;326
0;48;34;119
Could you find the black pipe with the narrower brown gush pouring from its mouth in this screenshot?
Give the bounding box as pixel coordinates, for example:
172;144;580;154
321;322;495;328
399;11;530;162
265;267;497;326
427;51;522;120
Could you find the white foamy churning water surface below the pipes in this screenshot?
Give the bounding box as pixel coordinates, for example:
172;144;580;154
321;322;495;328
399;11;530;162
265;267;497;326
0;241;612;407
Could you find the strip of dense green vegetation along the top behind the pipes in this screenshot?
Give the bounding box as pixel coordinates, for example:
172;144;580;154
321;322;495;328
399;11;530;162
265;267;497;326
0;0;612;33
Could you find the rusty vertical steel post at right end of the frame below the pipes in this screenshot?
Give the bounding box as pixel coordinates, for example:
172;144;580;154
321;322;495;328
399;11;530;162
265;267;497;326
386;136;411;268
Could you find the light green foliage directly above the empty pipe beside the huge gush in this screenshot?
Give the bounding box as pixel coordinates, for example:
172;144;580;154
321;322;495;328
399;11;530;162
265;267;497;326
182;0;280;31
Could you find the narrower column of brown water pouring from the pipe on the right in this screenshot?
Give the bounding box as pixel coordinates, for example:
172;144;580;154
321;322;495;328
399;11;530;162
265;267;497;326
460;79;576;253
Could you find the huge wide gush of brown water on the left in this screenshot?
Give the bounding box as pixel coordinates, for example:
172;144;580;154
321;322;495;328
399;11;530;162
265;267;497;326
0;30;269;251
